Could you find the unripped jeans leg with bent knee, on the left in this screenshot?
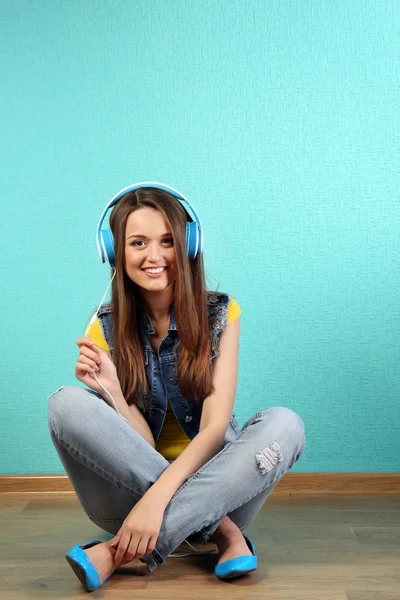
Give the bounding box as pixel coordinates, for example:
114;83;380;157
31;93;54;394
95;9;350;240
48;386;169;535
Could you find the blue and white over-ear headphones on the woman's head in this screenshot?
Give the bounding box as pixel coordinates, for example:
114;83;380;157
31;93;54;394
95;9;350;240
96;181;204;267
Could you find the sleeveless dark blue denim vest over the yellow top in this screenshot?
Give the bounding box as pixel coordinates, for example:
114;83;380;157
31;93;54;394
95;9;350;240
97;292;239;445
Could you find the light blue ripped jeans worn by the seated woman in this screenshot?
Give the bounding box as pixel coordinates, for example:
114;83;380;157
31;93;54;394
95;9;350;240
48;386;305;571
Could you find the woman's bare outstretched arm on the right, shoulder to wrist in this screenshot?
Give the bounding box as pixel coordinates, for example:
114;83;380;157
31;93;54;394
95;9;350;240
143;317;240;508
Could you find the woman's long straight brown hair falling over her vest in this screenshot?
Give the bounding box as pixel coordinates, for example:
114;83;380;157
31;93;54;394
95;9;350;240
105;187;214;404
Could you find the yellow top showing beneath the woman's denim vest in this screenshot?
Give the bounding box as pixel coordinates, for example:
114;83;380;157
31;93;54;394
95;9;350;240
85;297;241;460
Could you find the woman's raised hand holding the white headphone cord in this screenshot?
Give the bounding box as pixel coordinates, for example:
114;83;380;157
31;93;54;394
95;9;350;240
75;335;120;405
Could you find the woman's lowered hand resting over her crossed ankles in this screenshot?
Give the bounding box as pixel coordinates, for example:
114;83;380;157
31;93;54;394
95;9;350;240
111;496;165;566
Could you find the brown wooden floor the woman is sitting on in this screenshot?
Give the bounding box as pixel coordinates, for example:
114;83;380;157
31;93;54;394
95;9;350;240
0;493;400;600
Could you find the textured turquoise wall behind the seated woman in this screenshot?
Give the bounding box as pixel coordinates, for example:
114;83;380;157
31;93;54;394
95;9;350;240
0;0;400;473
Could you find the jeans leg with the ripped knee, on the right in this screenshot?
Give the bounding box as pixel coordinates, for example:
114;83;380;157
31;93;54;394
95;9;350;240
141;407;305;571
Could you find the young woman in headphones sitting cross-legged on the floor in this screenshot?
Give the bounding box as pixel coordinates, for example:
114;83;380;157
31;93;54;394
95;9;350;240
48;182;305;591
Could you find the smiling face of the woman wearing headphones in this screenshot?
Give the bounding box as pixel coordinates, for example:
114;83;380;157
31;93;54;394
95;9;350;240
125;206;176;292
